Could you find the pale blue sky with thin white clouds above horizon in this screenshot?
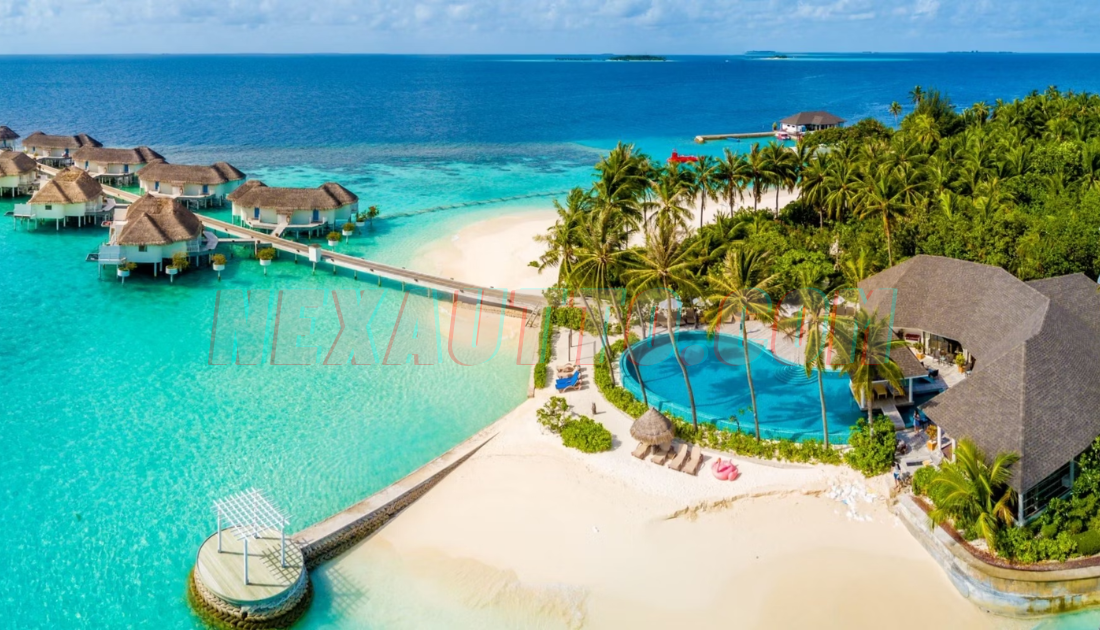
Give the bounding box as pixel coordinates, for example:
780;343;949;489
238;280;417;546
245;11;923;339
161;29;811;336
0;0;1100;55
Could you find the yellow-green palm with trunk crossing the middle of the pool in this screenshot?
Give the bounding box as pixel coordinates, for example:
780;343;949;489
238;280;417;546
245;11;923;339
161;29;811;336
707;246;776;440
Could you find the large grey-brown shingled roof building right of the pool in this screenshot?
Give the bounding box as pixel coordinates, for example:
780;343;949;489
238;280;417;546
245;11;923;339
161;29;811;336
859;256;1100;520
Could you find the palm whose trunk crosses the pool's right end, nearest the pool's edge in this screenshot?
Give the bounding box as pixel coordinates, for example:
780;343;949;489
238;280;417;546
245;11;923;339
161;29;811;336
779;272;834;447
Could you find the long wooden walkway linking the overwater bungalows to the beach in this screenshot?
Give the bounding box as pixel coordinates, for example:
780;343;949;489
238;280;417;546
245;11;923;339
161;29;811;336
39;164;546;310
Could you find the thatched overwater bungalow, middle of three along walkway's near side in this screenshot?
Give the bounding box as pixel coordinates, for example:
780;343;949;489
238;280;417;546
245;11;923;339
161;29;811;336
15;166;114;229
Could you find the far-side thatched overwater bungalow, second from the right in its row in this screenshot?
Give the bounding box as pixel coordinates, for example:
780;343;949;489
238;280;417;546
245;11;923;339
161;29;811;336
138;161;246;208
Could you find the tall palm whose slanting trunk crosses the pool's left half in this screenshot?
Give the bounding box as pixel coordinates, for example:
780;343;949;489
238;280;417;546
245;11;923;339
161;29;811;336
624;221;699;428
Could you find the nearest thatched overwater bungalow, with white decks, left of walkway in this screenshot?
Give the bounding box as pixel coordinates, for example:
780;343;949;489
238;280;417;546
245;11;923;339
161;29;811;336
98;195;218;275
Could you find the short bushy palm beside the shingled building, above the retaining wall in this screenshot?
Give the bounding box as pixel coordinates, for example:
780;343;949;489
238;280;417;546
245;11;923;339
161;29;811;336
928;438;1020;549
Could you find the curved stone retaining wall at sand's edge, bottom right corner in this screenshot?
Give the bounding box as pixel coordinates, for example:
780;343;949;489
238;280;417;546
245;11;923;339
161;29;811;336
894;495;1100;618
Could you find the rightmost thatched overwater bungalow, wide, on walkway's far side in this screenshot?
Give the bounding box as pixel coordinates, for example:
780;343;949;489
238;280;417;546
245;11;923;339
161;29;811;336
229;179;359;234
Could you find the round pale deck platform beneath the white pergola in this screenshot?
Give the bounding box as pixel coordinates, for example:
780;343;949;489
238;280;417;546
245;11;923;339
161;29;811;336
195;530;306;608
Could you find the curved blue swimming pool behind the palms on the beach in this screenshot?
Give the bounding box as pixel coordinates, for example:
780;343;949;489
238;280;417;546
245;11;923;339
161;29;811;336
619;331;862;443
